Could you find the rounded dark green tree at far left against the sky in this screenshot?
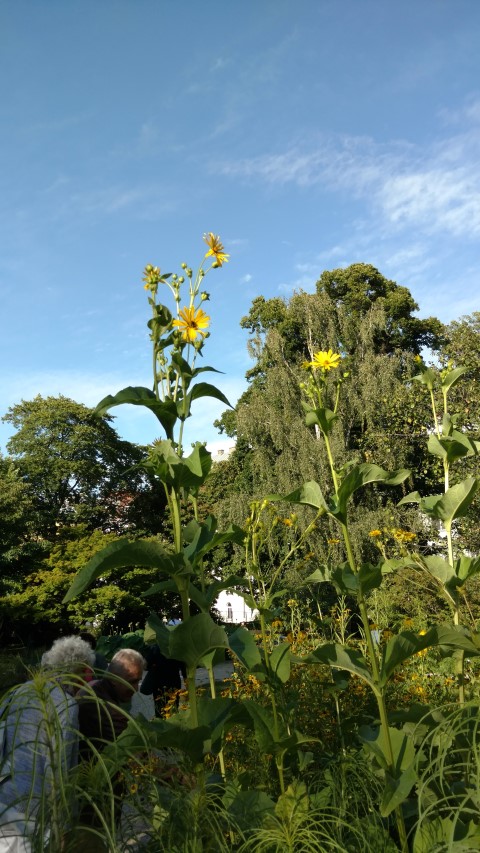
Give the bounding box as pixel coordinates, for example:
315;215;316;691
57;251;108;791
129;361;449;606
3;395;163;539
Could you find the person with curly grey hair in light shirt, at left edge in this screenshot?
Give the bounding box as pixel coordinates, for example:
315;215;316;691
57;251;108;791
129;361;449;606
0;637;95;853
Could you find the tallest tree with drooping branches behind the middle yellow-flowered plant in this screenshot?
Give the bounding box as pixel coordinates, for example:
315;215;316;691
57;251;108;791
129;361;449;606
212;264;444;576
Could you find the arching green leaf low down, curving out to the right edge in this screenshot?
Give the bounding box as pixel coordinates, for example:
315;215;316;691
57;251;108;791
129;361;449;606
380;625;479;685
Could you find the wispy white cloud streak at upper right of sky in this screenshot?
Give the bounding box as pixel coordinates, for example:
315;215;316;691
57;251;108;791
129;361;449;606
215;118;480;238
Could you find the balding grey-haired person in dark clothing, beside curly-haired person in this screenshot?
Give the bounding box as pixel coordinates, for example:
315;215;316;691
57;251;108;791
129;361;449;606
78;649;145;759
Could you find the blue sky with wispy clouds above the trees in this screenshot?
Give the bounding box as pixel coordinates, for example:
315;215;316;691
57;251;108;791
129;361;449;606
0;0;480;446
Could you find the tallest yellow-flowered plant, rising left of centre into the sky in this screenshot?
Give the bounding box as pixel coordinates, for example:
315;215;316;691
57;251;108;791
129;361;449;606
65;233;243;744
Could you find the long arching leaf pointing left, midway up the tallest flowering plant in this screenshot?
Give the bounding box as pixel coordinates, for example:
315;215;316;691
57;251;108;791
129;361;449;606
63;539;184;602
